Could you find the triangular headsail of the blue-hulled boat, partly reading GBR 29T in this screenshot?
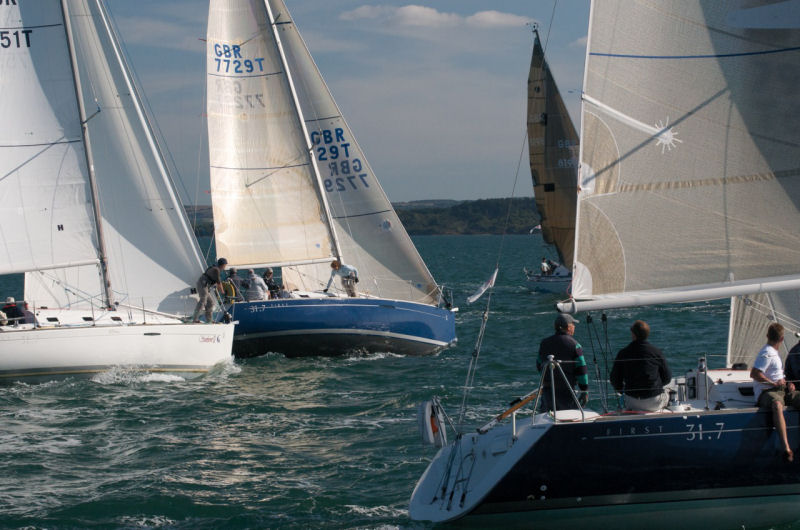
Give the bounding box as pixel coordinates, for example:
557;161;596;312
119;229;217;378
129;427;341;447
269;0;439;303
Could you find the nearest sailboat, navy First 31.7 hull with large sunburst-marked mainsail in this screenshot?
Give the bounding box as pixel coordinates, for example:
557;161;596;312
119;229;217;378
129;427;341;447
409;0;800;528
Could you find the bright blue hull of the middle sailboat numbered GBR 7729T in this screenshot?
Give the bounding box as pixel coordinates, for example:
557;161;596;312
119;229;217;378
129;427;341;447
229;298;456;357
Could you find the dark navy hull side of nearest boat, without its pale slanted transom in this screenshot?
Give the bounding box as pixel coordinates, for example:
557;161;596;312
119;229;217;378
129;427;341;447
472;411;800;521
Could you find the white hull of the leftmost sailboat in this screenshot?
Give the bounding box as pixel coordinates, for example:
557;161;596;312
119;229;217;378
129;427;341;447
0;323;233;380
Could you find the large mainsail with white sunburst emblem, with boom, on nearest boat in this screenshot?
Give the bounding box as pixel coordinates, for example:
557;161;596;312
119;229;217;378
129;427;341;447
561;0;800;310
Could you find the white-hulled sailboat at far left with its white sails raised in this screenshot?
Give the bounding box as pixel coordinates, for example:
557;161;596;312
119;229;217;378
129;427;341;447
0;0;233;379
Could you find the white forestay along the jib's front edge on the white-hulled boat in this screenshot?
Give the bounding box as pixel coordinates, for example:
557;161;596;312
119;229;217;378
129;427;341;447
96;0;205;268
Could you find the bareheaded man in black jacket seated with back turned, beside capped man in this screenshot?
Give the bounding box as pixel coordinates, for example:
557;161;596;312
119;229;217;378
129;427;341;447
609;320;672;411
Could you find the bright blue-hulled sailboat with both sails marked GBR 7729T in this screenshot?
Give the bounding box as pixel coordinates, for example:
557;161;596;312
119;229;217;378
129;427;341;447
207;0;456;357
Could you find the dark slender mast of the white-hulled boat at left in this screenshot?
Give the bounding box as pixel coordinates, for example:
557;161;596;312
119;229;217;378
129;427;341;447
61;0;114;309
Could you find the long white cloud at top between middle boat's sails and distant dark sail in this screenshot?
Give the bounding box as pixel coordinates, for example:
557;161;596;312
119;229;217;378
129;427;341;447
339;4;530;28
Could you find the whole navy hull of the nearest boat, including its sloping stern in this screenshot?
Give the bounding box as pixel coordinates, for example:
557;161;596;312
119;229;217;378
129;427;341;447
409;409;800;528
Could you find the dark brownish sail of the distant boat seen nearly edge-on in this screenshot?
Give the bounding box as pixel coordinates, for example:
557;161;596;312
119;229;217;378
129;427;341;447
528;30;578;268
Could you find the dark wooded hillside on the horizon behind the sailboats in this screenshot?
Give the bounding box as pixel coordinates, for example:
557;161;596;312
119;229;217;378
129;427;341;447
186;197;539;236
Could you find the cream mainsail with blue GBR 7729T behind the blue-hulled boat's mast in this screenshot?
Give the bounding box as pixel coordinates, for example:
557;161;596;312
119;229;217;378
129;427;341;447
207;0;336;266
